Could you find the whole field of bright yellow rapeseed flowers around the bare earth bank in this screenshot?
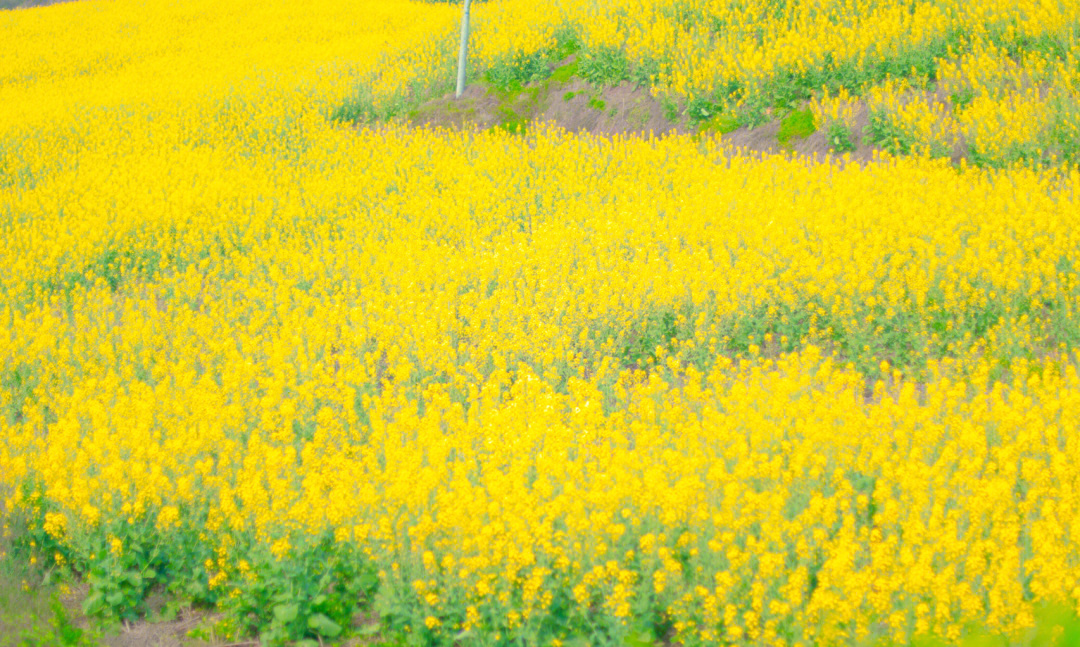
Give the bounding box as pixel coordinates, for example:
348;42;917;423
6;0;1080;647
